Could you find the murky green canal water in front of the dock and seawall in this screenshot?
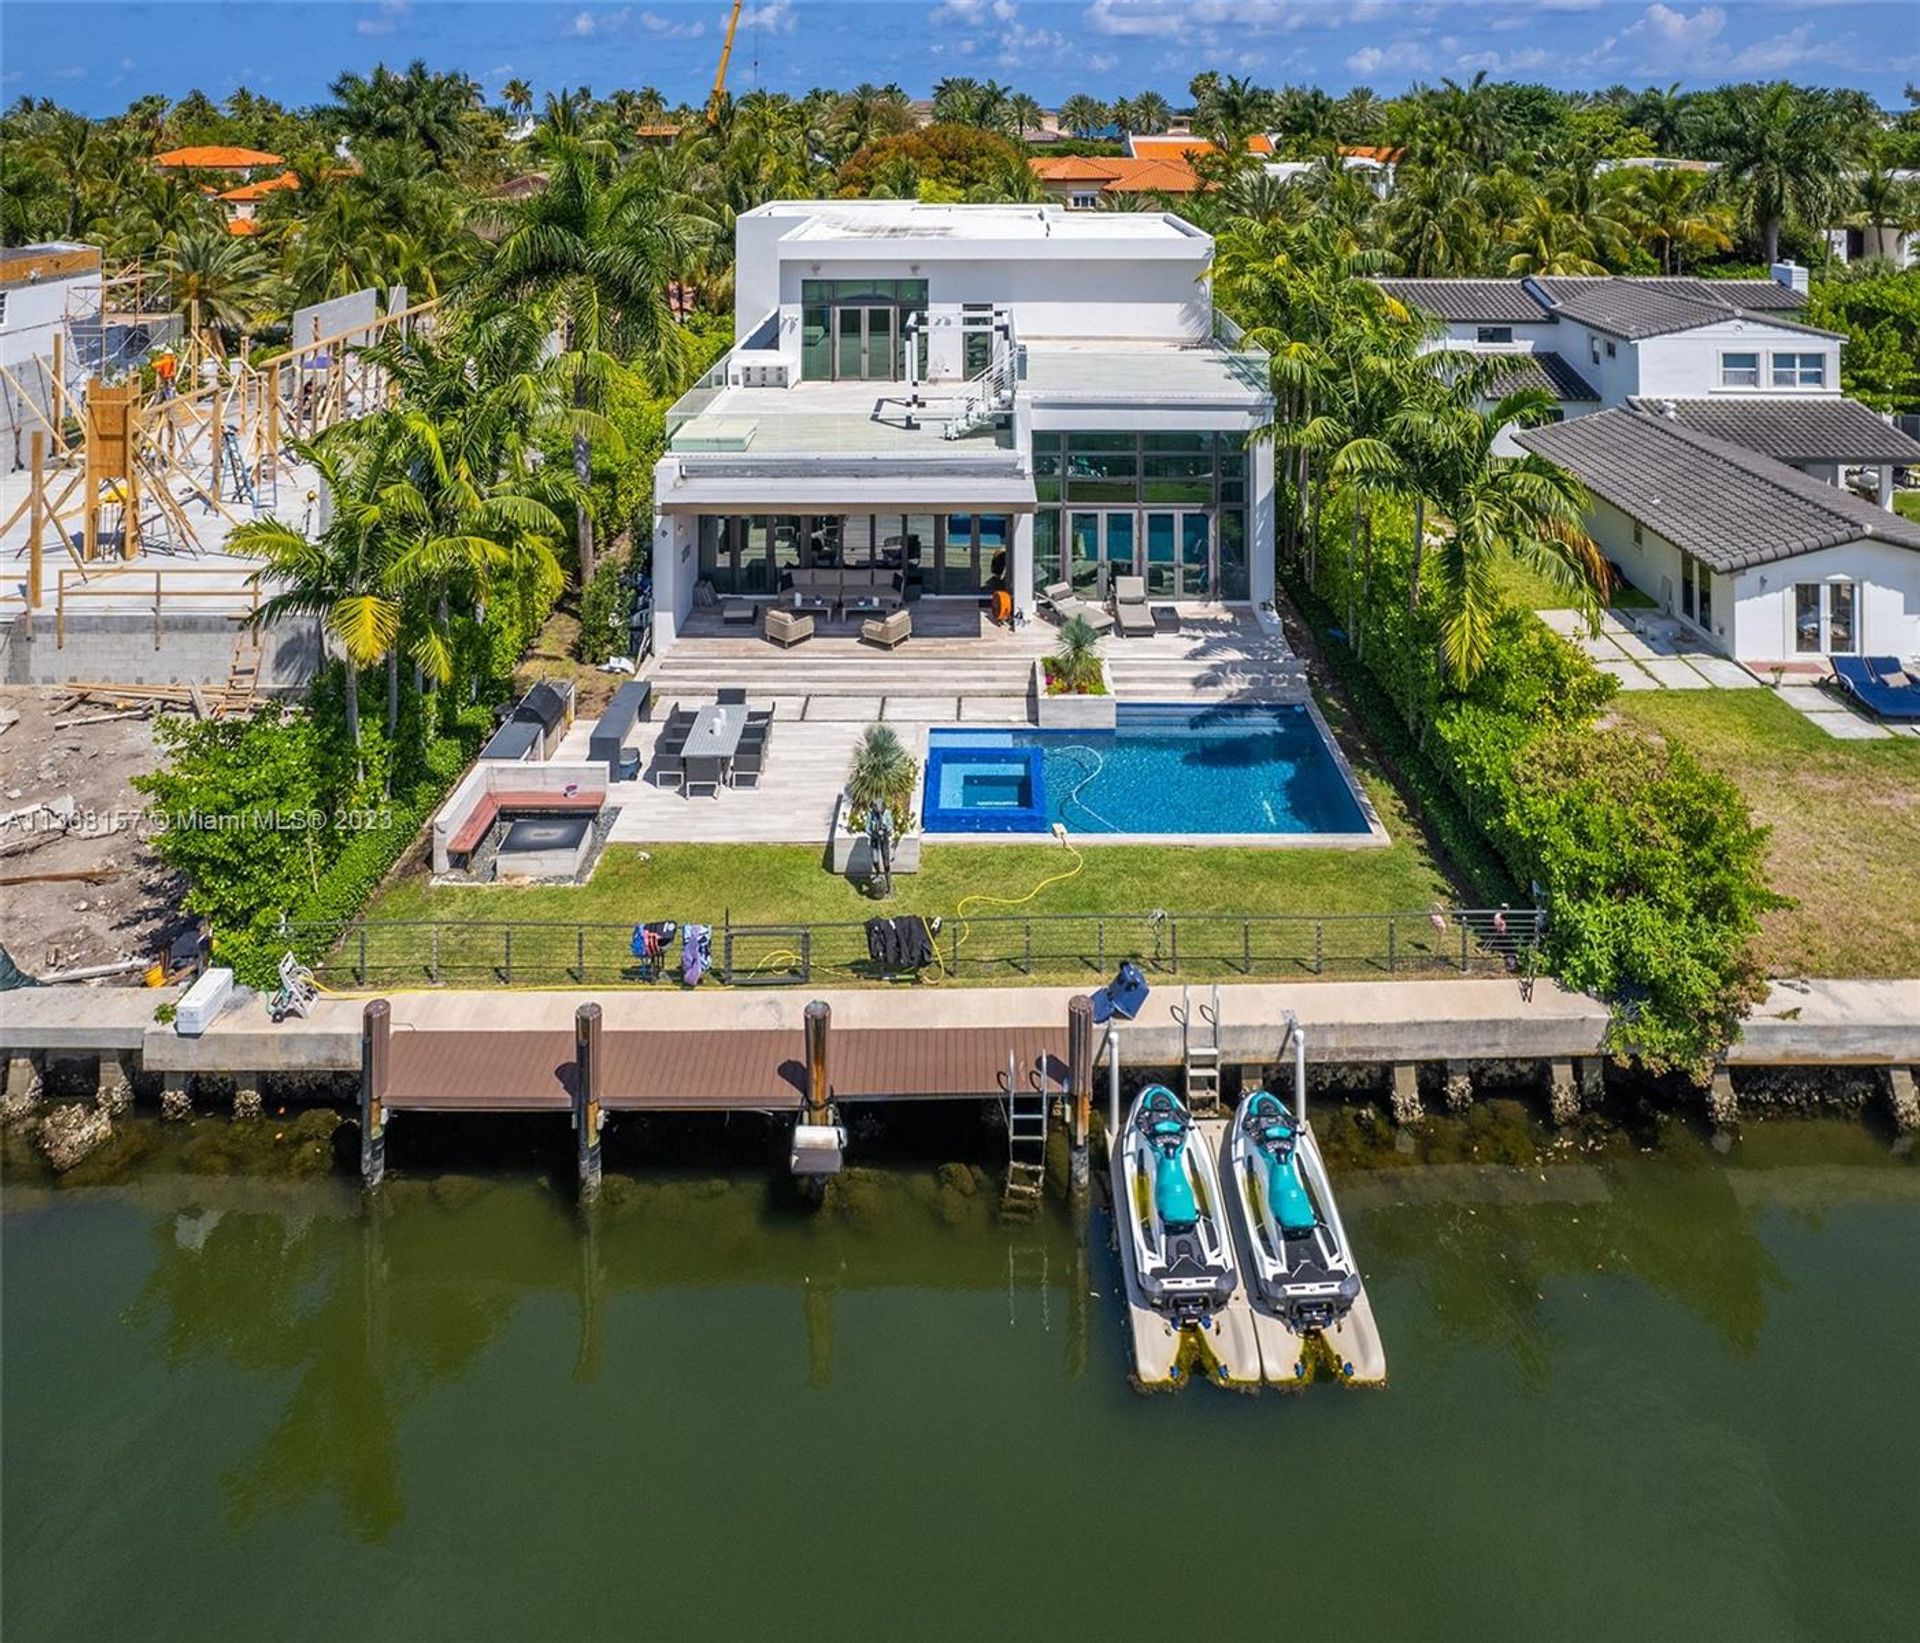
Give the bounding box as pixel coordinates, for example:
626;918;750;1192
0;1121;1920;1643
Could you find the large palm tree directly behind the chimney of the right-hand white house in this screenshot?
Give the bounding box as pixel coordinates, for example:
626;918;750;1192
1707;81;1859;263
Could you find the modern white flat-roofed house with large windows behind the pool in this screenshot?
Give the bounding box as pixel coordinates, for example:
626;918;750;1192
653;200;1273;649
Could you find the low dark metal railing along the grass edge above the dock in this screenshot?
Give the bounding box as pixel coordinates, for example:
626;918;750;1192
282;904;1544;988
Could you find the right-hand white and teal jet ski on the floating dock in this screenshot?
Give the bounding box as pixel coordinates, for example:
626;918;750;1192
1229;1090;1359;1334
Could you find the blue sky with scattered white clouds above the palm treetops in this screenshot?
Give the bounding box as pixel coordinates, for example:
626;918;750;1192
0;0;1920;113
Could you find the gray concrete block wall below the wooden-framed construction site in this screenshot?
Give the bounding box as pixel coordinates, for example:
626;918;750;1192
0;610;321;691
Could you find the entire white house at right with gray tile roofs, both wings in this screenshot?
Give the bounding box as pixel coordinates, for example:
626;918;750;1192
1382;263;1920;662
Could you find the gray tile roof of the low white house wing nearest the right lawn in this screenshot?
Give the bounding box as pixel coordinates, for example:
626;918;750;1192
1515;411;1920;572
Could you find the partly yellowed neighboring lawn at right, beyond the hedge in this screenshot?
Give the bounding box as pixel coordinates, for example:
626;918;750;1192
1613;691;1920;975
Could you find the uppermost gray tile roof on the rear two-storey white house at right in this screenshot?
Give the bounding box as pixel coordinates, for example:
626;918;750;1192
1379;274;1834;340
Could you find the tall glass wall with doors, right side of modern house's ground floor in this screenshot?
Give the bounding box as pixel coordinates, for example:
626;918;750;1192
1033;434;1252;599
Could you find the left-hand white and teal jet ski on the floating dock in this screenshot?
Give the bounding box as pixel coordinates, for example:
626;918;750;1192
1117;1084;1235;1328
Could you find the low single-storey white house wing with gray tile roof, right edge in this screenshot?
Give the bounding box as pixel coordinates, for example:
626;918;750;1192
1519;401;1920;666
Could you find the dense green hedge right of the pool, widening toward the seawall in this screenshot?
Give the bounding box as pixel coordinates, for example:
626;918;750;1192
1304;514;1784;1077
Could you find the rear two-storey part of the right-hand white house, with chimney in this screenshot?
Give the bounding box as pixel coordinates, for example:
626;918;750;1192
1380;263;1835;461
